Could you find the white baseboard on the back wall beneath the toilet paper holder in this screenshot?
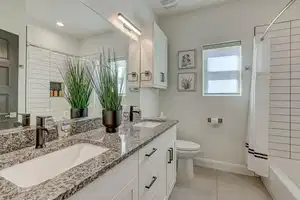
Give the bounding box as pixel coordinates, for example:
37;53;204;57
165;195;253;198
195;157;255;176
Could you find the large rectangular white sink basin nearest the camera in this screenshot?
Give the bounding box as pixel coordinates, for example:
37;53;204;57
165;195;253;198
0;143;108;187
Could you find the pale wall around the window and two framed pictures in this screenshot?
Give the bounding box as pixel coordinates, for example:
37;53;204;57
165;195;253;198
159;0;300;164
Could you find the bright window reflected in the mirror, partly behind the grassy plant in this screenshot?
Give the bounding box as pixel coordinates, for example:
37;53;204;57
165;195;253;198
111;58;127;96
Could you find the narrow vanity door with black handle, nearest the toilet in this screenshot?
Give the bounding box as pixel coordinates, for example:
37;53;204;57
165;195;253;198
167;141;176;196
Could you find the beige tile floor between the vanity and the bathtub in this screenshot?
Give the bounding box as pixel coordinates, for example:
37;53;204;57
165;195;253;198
170;167;272;200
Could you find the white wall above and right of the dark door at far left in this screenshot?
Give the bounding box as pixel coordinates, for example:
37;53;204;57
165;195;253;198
0;0;26;112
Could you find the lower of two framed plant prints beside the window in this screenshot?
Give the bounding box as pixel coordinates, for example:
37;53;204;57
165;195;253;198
177;72;197;92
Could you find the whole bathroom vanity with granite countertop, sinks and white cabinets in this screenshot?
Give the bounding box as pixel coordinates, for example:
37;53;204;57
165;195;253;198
0;121;177;200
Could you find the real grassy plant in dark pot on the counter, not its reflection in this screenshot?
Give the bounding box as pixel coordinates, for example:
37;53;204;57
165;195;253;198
89;51;124;133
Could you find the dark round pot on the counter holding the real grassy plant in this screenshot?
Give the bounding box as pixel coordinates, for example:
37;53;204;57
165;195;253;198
102;110;122;133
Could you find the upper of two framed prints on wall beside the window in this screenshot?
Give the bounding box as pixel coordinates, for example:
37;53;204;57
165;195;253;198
178;49;196;70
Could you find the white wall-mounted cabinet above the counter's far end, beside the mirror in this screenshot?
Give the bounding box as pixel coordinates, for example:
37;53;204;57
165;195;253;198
140;22;168;89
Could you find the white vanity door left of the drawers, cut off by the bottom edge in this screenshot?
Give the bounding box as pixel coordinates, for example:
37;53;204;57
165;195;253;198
112;177;138;200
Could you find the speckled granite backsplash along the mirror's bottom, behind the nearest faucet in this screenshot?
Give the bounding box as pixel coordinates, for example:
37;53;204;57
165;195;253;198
0;117;102;155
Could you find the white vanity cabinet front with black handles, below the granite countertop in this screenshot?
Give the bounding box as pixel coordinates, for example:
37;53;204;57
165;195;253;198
69;126;176;200
